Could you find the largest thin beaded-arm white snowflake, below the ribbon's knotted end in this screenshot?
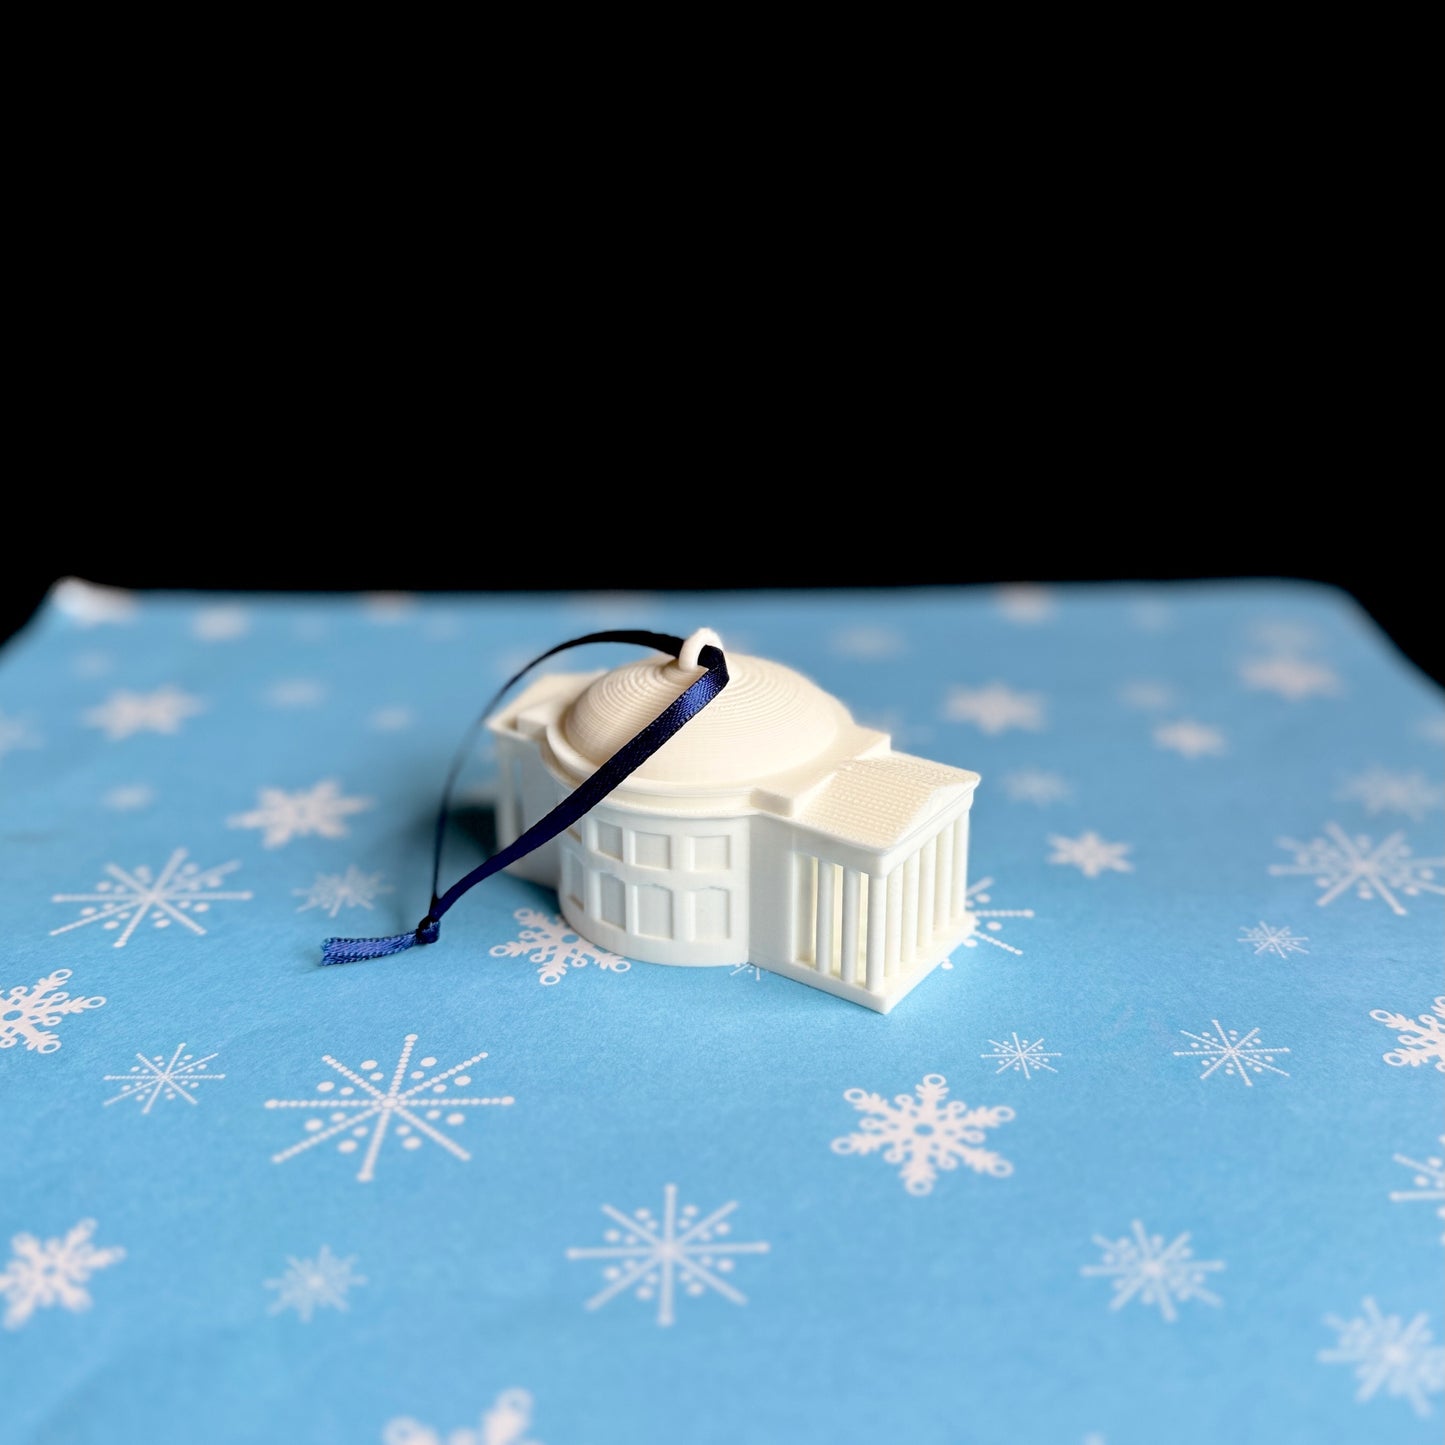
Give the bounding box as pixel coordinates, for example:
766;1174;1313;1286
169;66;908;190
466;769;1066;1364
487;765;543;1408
266;1033;514;1182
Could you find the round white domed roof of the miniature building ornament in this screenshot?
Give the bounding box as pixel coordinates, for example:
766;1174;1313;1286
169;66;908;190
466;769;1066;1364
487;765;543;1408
562;634;853;788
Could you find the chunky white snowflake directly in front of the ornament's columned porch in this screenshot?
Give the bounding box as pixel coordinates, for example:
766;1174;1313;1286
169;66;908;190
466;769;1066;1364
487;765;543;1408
832;1074;1014;1195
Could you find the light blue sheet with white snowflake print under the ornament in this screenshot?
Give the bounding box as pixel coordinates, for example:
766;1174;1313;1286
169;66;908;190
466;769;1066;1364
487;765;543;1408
0;582;1445;1445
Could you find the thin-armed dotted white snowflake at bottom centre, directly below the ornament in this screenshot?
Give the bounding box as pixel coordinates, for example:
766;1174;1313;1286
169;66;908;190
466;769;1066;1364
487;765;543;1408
566;1183;767;1325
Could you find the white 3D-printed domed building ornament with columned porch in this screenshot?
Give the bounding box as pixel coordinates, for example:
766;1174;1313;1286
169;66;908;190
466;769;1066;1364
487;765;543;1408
488;629;978;1013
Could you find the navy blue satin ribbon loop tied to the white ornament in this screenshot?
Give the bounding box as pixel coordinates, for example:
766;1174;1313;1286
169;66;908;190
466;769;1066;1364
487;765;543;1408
321;631;728;964
